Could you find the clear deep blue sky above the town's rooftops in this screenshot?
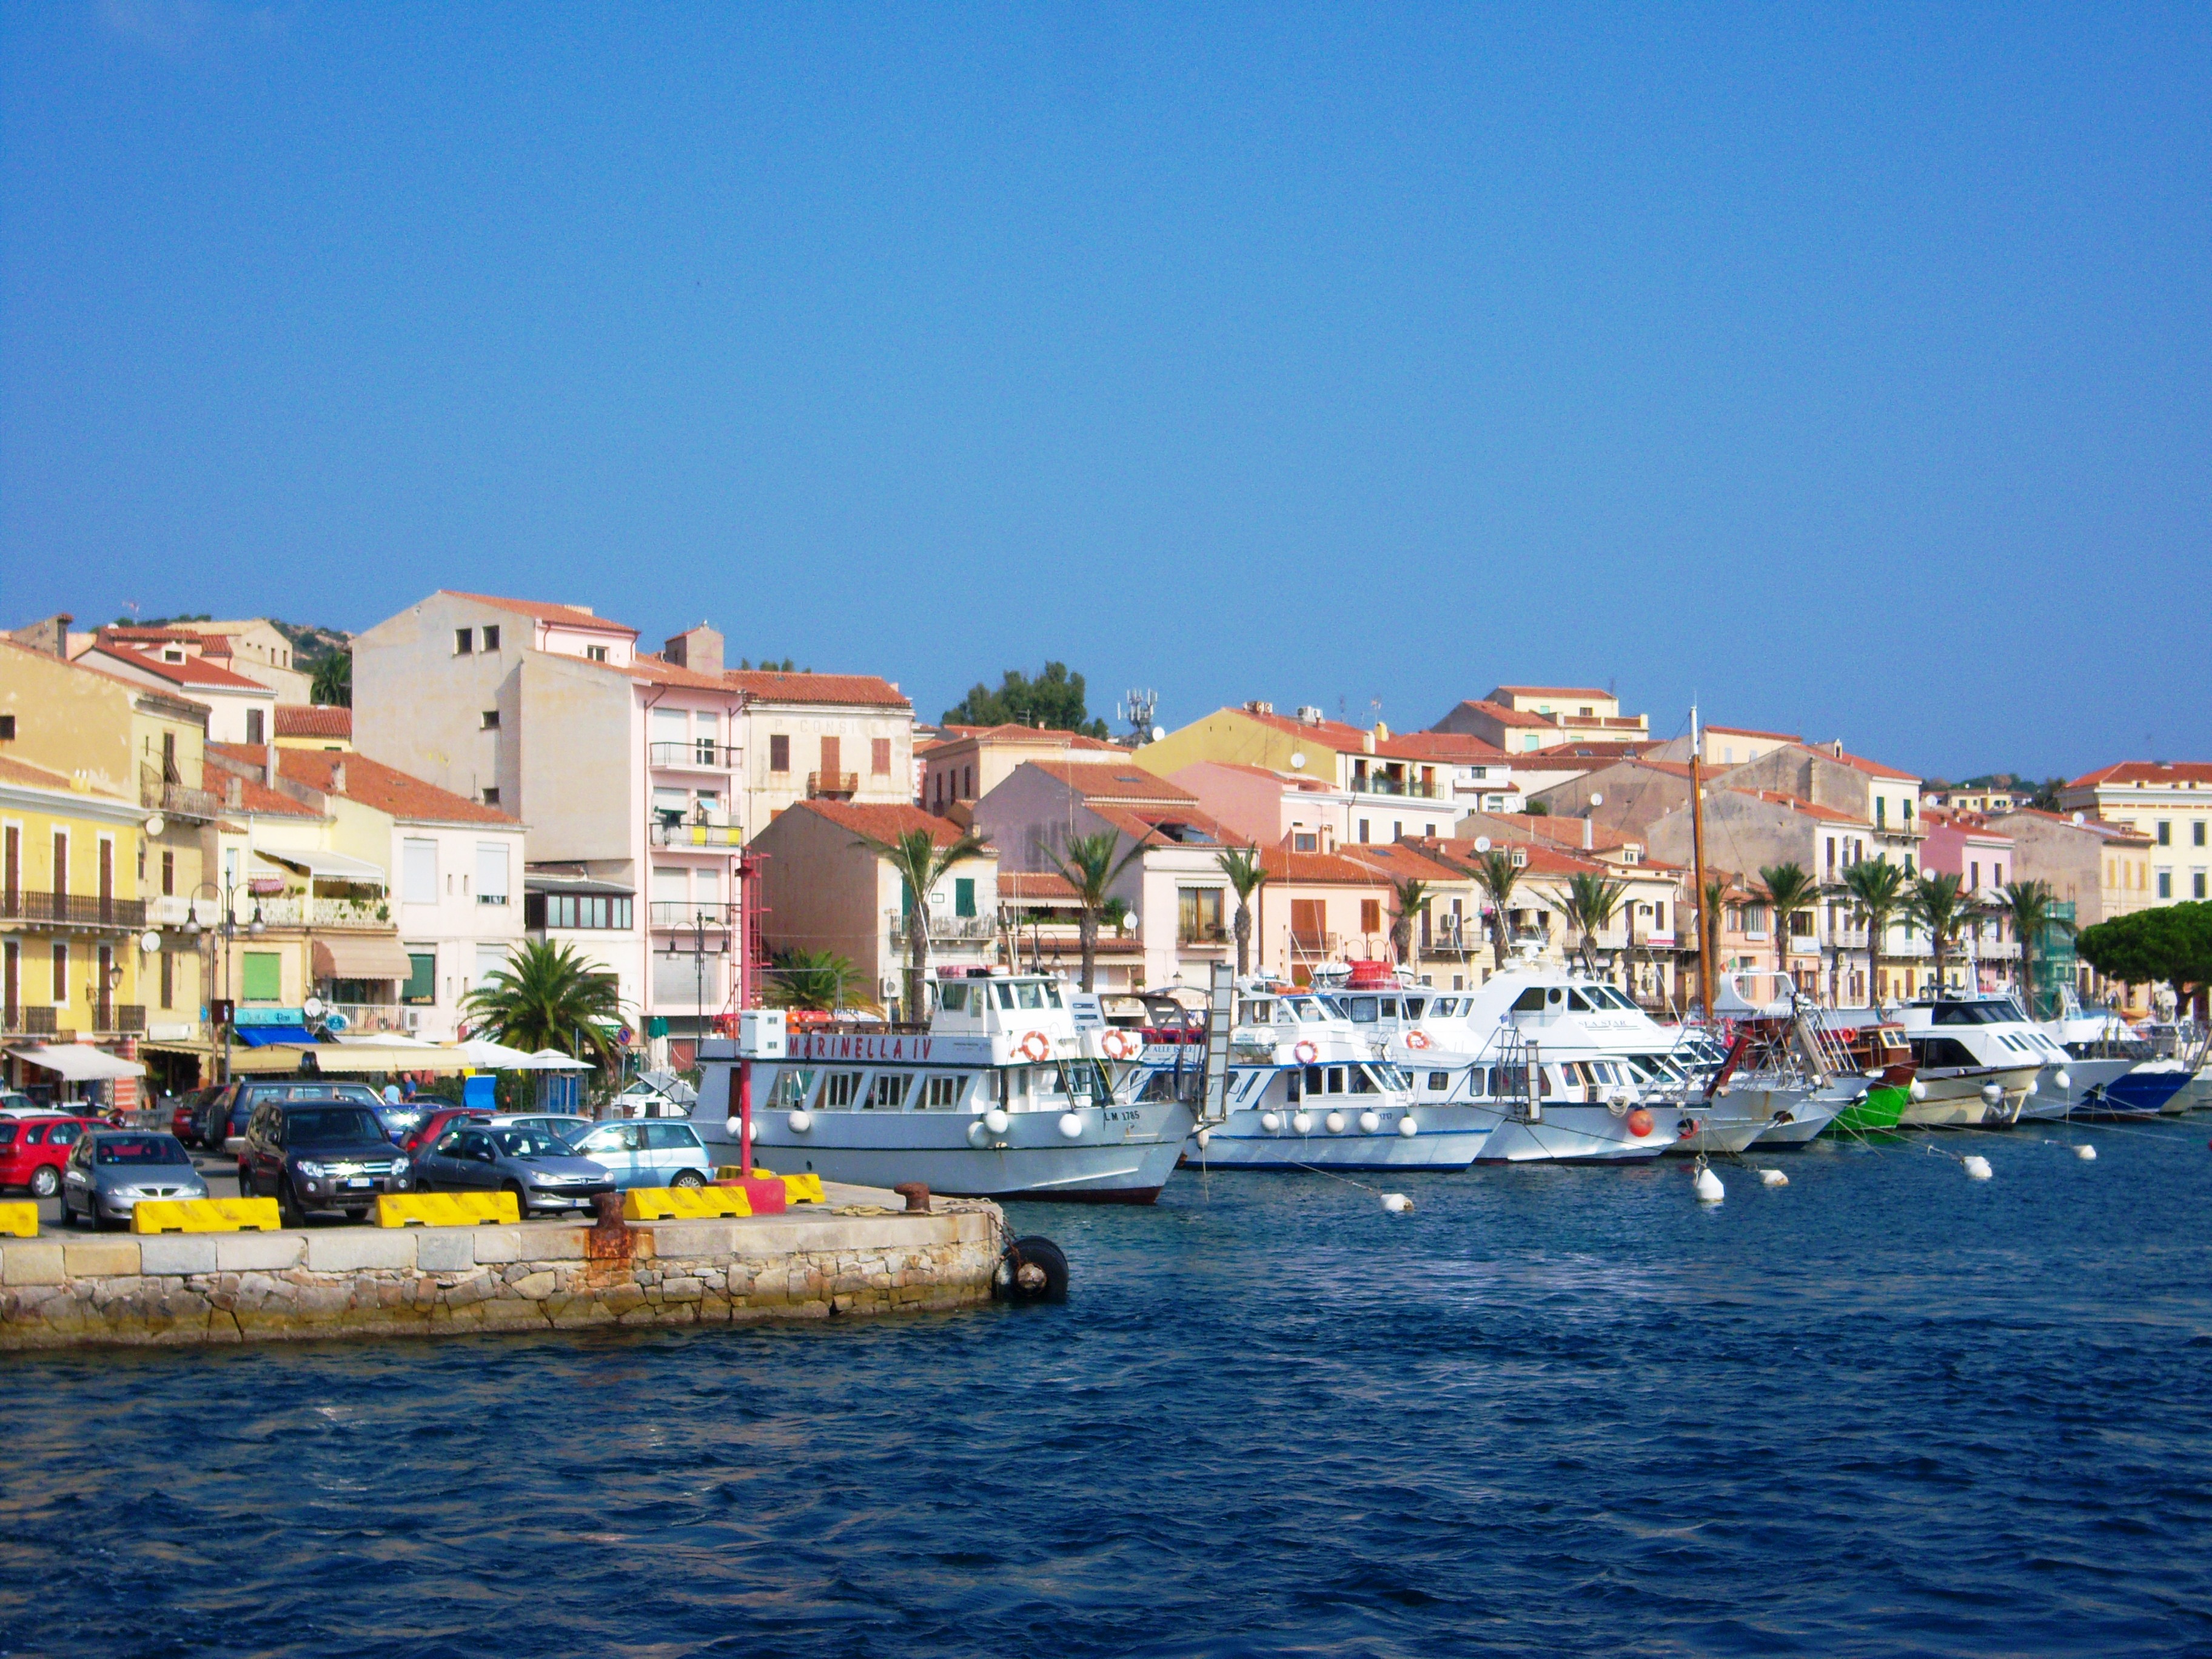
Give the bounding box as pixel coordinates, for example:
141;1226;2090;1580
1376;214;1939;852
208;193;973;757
0;0;2212;774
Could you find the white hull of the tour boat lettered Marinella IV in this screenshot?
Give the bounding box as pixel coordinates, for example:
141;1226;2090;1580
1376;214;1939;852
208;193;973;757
694;1102;1190;1204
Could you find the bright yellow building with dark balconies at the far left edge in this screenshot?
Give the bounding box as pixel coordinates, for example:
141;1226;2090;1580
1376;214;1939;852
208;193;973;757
0;754;152;1108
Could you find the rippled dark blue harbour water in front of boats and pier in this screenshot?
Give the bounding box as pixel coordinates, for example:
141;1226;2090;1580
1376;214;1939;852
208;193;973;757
0;1119;2212;1659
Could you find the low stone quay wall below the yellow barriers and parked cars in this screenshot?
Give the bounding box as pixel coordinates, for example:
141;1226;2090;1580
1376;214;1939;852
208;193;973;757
0;1204;1000;1349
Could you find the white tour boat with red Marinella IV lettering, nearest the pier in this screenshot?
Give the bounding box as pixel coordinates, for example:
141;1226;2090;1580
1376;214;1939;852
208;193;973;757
694;973;1195;1204
